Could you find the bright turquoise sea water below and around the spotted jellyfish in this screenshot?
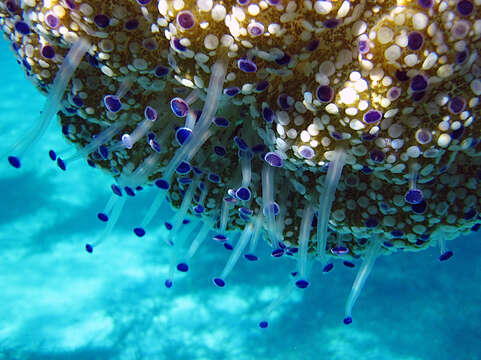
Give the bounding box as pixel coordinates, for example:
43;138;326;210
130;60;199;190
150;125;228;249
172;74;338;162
0;37;481;360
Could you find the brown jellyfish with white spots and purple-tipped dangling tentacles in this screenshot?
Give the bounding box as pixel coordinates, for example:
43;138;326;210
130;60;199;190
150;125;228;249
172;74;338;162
0;0;481;328
